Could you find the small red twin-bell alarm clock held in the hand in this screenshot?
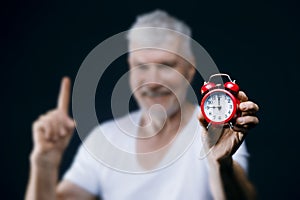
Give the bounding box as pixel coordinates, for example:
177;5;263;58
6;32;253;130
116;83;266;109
200;74;240;126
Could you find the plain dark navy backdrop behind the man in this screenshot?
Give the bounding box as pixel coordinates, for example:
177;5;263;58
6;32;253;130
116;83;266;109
0;0;300;199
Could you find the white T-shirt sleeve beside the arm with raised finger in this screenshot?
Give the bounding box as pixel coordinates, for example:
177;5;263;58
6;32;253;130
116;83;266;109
63;145;101;196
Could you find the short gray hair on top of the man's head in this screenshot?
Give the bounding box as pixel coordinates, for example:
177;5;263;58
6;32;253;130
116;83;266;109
127;10;193;58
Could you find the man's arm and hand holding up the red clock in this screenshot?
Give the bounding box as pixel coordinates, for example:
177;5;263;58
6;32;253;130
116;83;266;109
199;92;259;200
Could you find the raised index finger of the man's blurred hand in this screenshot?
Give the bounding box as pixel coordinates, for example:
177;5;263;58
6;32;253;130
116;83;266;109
57;77;71;113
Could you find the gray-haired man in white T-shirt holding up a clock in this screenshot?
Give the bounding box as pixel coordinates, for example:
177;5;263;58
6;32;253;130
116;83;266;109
26;11;258;200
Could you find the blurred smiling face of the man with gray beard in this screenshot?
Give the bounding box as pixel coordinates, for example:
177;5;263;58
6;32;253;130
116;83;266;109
129;49;195;116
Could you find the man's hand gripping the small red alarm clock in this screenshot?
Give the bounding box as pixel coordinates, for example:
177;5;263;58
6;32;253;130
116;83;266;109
198;91;259;161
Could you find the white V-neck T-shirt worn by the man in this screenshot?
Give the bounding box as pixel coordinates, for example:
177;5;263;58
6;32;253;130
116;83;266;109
64;107;249;200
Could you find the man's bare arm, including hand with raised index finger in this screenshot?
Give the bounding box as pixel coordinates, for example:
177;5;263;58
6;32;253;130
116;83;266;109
25;78;96;200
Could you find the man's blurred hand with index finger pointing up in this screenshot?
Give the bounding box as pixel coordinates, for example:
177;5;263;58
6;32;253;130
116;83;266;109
31;78;75;168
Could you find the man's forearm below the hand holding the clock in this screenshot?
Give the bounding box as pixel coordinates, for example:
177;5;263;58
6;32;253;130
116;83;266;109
209;159;256;199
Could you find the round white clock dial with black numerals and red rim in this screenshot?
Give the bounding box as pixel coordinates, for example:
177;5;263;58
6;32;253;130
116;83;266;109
201;89;237;124
